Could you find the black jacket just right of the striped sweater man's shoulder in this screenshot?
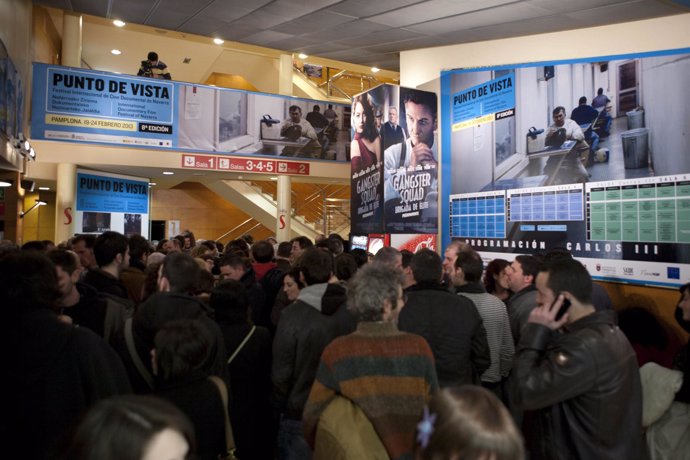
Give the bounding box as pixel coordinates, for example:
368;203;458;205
398;283;491;387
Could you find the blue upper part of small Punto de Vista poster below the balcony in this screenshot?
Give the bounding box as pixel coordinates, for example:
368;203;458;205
77;173;149;214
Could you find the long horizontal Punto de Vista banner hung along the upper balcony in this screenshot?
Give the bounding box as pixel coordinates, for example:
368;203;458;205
31;64;350;161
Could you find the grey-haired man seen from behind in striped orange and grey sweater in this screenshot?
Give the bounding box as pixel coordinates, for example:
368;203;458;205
303;262;438;458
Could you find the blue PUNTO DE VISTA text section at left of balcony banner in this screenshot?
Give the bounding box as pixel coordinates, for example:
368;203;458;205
31;64;176;148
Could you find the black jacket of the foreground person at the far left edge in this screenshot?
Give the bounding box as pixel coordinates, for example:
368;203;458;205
0;305;131;459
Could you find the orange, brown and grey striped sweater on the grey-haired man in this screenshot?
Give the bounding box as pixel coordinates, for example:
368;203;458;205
302;322;438;459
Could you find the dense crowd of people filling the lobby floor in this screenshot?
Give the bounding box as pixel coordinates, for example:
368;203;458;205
0;231;690;460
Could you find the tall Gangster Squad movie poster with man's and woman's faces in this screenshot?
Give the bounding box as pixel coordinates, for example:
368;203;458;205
350;85;439;234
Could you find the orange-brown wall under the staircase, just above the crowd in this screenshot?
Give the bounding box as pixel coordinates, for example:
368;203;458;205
150;182;275;243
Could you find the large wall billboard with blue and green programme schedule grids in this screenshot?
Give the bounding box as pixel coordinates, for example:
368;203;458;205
441;49;690;287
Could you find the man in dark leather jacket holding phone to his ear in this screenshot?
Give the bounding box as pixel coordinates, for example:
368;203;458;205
515;260;644;460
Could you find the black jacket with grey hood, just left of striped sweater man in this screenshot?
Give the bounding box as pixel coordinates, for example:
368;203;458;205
271;283;355;420
